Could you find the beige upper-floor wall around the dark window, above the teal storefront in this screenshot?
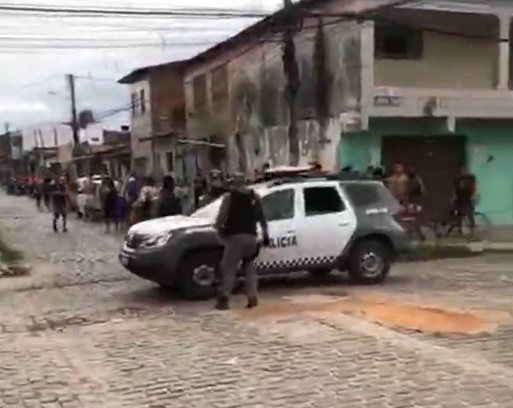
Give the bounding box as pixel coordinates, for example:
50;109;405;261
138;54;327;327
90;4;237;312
374;10;499;90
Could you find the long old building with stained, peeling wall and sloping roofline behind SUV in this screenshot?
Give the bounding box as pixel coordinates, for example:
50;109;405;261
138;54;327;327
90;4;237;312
184;0;369;175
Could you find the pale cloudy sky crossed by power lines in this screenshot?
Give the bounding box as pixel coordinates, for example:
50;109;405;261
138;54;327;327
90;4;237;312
0;0;282;130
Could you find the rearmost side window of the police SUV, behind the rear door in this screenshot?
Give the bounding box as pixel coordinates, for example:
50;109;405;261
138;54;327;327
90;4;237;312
342;183;399;212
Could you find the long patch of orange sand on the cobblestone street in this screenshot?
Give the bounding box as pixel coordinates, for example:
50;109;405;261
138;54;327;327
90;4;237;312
233;298;503;335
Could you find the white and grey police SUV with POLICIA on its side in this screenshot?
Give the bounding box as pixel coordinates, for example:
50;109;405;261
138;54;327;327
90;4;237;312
119;167;409;299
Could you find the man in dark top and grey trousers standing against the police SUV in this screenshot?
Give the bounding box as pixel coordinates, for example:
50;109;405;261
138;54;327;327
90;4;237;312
214;174;269;310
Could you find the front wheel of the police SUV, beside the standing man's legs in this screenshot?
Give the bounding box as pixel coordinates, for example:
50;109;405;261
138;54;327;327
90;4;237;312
178;250;223;300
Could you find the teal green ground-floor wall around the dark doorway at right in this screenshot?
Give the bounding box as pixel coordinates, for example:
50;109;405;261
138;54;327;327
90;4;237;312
338;118;513;225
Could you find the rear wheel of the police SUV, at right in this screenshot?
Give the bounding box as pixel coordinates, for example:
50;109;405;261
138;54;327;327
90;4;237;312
347;239;392;285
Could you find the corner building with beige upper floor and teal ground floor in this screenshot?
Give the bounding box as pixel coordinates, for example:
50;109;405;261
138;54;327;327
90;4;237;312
339;0;513;224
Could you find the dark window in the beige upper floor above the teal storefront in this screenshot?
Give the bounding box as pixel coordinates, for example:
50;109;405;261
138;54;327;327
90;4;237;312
374;24;424;60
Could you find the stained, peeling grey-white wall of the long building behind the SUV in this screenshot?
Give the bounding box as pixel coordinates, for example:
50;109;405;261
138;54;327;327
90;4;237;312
185;0;361;174
